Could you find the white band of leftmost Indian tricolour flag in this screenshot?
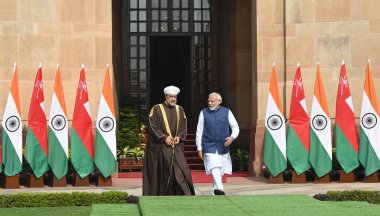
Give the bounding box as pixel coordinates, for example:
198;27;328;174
2;92;22;163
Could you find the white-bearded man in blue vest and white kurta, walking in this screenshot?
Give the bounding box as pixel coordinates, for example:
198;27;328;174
196;92;239;195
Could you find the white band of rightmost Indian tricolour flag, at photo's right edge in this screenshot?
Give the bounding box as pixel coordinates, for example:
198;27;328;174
360;91;380;159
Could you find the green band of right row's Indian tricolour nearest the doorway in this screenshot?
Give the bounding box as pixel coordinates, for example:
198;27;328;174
264;129;287;177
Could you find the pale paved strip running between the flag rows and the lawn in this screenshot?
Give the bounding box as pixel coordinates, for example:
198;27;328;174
0;177;380;196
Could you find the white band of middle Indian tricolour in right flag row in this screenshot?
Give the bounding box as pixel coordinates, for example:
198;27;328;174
310;95;332;159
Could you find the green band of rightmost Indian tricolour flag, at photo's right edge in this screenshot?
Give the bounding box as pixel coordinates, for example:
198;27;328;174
359;127;380;176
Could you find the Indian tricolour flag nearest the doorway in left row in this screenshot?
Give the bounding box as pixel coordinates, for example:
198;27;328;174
95;67;116;177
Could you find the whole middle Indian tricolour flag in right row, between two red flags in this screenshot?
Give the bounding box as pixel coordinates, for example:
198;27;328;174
309;63;332;177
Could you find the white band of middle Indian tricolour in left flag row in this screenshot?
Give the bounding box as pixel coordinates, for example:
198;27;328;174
49;92;69;157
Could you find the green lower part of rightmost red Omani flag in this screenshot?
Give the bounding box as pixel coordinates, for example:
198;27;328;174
335;124;359;173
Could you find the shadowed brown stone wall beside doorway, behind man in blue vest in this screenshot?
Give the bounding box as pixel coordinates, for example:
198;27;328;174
217;0;252;149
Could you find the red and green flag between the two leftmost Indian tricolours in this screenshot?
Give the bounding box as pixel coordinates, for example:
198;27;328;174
26;65;49;178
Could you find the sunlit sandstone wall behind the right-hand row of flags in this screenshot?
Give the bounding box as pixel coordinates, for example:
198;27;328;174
252;0;380;174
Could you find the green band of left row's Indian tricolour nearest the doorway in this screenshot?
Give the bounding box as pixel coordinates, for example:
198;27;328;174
94;129;116;177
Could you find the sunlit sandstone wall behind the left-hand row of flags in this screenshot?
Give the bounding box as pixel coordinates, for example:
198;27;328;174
0;0;112;121
